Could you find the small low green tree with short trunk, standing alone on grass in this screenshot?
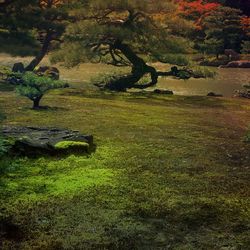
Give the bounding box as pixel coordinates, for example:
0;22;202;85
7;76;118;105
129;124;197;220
16;72;68;109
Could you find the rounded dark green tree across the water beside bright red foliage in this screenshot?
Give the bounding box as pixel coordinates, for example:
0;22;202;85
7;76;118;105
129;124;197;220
201;6;243;57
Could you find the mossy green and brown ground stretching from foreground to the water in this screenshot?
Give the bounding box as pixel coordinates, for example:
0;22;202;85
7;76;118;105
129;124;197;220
0;64;250;250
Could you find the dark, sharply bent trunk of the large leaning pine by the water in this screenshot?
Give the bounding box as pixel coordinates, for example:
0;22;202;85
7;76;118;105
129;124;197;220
99;40;158;91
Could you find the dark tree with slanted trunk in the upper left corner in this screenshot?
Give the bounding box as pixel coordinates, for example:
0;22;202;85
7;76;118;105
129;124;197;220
0;0;72;71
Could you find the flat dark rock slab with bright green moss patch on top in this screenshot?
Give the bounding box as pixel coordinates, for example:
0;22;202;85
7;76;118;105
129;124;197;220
2;126;94;156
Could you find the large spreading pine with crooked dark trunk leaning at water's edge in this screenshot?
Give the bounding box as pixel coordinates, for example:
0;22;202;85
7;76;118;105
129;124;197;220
53;0;208;91
